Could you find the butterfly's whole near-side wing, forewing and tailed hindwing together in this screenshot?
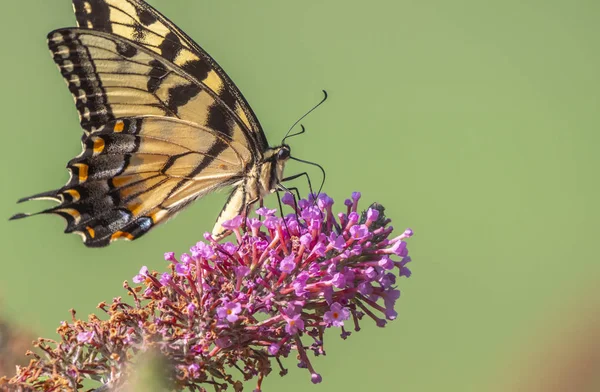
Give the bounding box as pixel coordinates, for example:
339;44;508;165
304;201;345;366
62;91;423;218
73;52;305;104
14;29;257;246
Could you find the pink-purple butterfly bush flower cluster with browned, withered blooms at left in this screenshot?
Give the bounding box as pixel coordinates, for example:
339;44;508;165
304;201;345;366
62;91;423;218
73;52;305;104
5;192;412;391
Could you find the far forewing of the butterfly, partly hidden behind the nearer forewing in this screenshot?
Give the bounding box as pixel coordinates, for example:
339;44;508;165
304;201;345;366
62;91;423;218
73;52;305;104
73;0;269;154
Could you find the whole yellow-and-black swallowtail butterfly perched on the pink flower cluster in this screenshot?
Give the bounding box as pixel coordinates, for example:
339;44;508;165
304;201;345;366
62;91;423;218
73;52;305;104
11;0;308;247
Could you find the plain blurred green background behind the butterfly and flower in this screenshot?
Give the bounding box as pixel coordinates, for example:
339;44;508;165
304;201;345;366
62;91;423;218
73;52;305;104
0;0;600;391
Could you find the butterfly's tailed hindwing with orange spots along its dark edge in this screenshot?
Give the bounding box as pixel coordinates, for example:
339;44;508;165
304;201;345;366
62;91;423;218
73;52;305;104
15;117;243;247
